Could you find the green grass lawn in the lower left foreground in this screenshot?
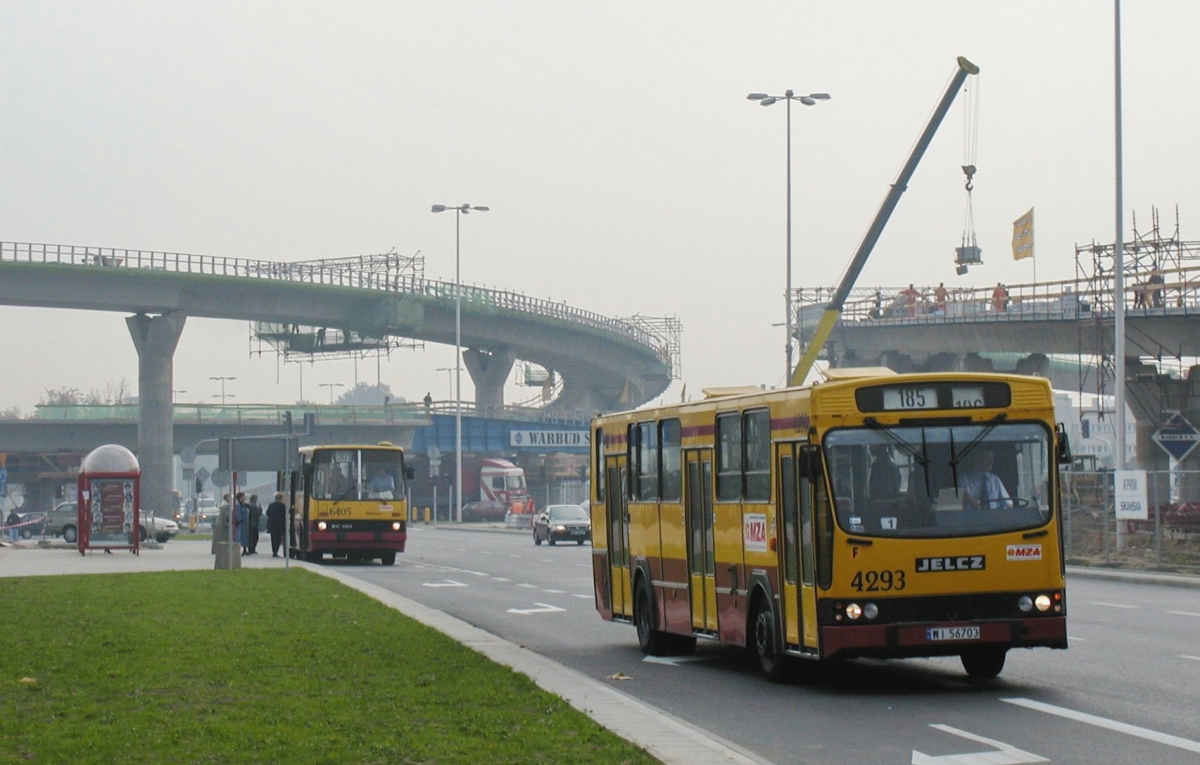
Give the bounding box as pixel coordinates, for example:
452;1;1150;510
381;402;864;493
0;568;656;765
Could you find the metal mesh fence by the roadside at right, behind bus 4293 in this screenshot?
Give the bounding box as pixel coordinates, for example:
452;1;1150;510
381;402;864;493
1062;471;1200;573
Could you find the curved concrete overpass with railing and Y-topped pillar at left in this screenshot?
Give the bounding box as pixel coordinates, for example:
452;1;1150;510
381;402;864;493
0;242;678;512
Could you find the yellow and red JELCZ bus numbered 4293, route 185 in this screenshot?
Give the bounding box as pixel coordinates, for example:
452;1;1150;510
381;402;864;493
590;368;1070;680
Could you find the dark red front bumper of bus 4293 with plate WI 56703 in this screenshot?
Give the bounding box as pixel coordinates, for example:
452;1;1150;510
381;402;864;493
821;616;1067;658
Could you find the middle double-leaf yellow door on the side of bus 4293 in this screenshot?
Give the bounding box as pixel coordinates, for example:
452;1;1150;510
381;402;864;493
686;448;718;633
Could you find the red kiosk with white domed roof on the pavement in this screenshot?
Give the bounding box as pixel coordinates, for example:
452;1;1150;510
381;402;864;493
77;444;142;555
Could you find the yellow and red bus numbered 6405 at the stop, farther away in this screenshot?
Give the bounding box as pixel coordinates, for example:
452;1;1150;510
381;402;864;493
290;441;410;566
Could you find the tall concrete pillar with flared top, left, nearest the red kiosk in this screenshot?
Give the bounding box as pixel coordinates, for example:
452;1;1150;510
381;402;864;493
125;313;187;518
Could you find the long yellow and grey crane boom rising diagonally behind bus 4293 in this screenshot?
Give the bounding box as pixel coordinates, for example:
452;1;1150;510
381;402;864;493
791;56;979;385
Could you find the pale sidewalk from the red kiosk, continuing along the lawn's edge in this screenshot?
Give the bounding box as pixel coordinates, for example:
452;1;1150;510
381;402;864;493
0;539;770;765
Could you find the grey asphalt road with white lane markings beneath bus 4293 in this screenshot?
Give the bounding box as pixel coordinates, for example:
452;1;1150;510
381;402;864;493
326;526;1200;765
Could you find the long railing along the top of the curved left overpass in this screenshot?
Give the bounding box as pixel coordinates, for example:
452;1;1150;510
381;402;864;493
0;242;672;367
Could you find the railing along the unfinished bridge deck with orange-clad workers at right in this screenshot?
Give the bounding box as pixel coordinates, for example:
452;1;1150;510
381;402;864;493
794;266;1200;331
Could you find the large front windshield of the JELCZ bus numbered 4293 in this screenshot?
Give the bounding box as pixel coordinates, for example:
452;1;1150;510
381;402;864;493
824;420;1051;537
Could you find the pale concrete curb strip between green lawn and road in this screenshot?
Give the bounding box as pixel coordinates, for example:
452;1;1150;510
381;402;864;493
304;563;770;765
